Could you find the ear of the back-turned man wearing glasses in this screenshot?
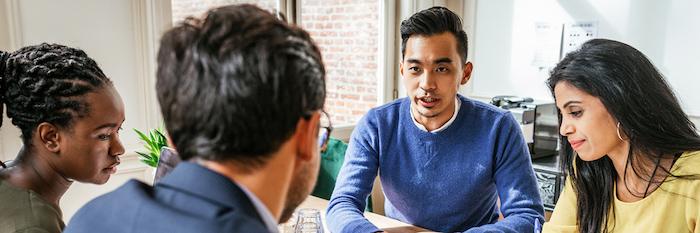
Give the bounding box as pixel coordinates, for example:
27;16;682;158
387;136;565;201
294;112;321;161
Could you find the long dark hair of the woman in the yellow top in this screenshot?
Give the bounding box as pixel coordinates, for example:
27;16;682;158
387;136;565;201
547;39;700;233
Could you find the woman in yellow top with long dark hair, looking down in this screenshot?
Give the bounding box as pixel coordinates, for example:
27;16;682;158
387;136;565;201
543;39;700;233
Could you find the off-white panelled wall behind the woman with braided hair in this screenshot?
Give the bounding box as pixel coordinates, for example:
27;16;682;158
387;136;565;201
0;0;163;221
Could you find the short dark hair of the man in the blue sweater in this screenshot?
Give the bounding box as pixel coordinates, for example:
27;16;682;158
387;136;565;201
400;6;467;63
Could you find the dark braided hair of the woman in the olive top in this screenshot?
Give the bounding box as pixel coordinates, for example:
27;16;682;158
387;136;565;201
0;43;112;146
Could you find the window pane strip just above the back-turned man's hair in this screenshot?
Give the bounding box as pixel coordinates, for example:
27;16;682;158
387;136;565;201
171;0;277;24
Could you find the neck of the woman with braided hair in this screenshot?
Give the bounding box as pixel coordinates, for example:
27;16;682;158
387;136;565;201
7;148;73;209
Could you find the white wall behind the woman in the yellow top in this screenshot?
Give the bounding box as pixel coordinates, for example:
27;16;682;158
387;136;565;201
467;0;700;122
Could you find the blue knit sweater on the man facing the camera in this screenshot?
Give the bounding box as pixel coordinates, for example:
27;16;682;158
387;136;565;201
327;95;544;233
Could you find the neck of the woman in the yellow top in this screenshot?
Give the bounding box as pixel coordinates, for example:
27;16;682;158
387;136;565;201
608;140;673;202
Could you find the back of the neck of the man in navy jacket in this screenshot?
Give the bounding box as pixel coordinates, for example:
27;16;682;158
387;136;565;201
200;143;294;221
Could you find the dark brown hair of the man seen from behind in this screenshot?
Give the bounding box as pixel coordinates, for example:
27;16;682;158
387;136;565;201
157;4;326;167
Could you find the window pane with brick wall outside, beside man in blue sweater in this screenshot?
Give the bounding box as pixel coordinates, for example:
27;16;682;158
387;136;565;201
301;0;380;126
